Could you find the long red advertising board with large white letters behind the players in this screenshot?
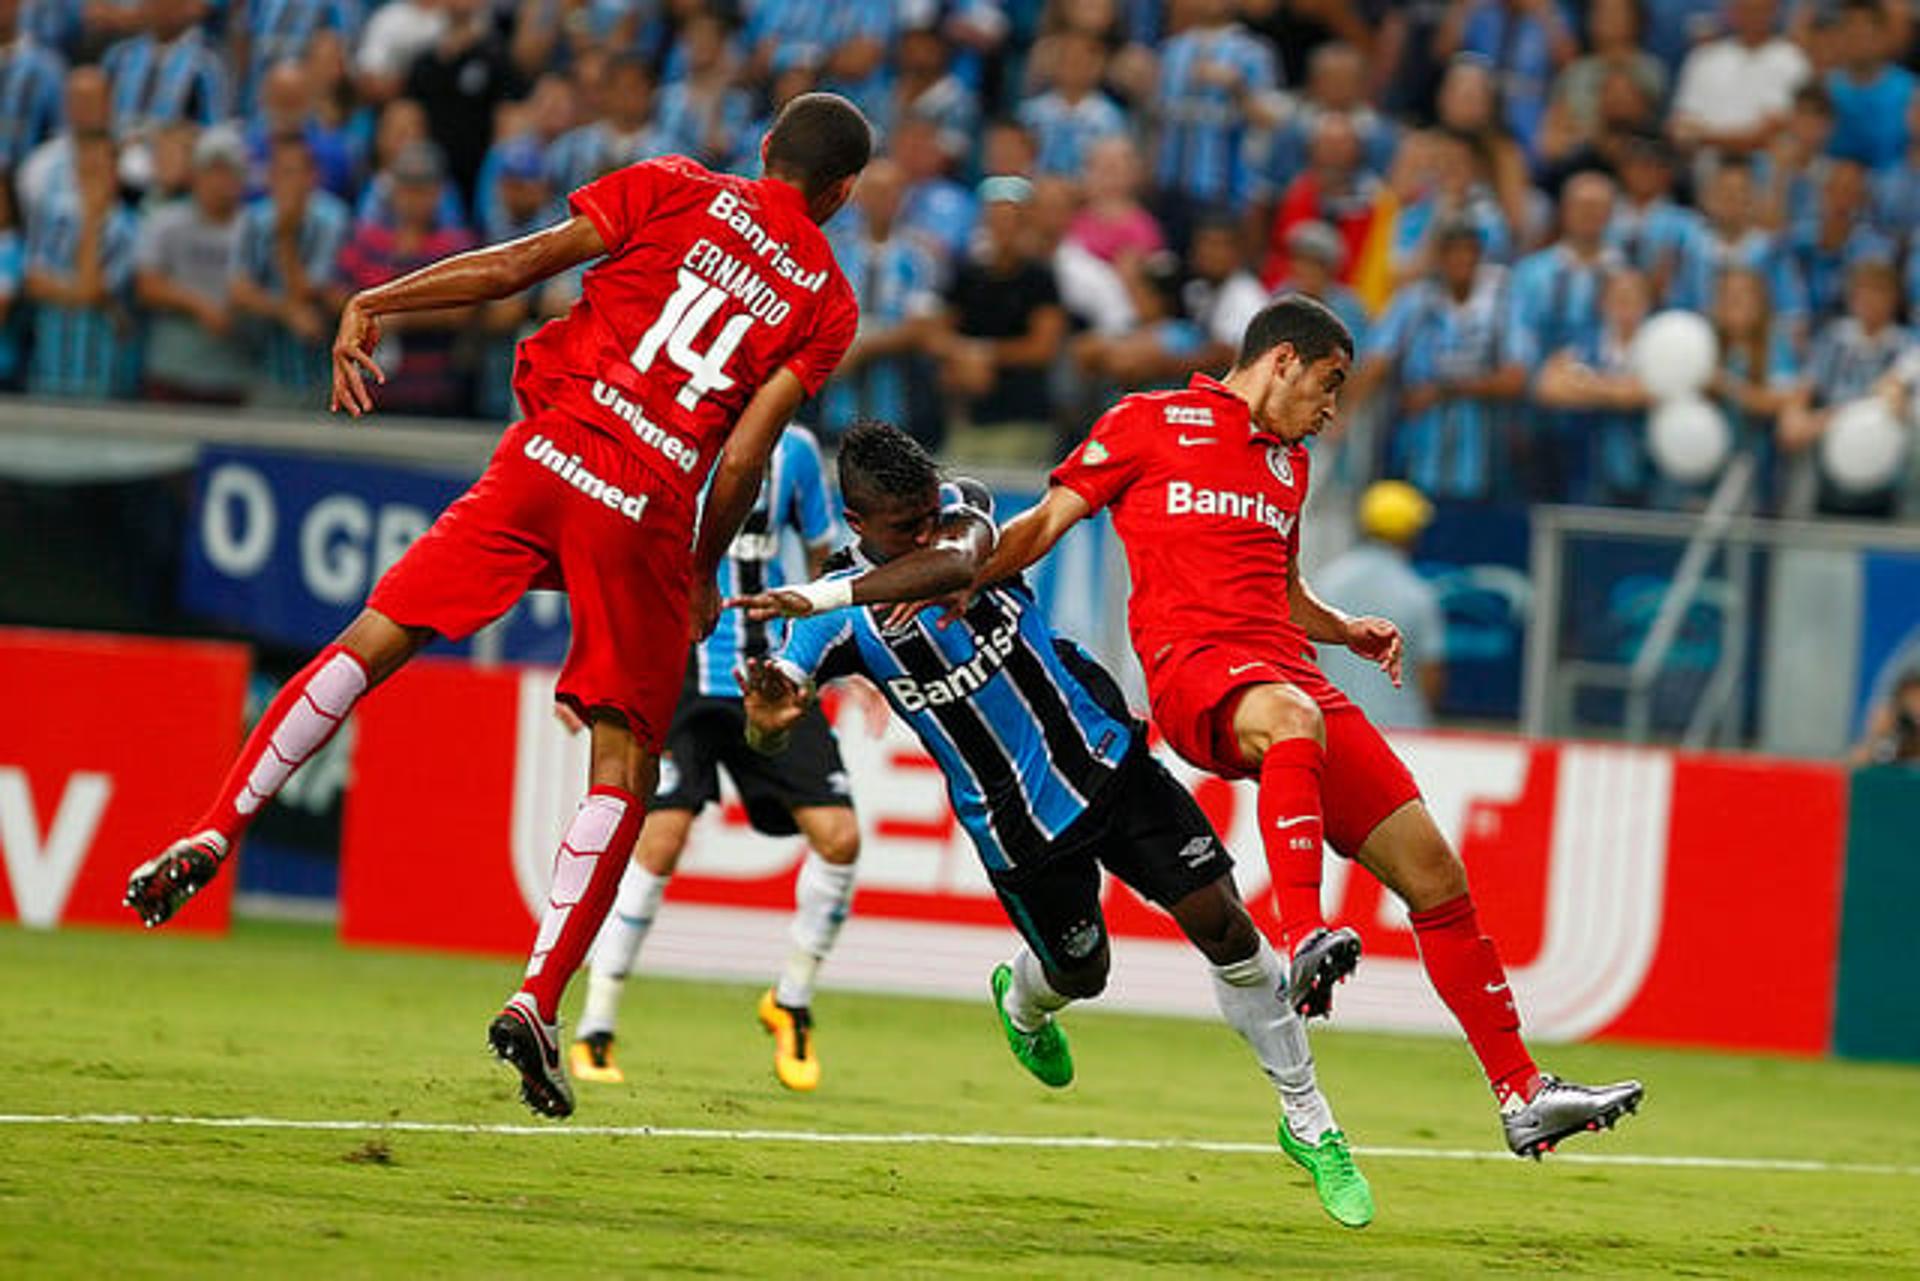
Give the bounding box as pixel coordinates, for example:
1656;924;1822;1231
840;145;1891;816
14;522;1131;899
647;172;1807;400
342;665;1845;1052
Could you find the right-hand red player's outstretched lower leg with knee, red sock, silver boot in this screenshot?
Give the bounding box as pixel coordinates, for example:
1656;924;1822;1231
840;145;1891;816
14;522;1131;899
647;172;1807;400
1357;801;1645;1158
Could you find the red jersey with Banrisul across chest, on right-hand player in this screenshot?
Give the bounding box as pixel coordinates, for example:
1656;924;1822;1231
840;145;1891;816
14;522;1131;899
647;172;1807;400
1052;375;1313;676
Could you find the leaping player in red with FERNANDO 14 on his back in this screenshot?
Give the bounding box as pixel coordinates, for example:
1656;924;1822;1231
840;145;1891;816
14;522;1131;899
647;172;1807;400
127;94;872;1116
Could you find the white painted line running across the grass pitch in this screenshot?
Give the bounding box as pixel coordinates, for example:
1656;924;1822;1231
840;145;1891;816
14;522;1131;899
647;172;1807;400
0;1112;1920;1177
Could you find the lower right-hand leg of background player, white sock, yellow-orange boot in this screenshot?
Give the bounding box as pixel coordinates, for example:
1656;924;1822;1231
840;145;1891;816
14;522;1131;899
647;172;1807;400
758;805;860;1091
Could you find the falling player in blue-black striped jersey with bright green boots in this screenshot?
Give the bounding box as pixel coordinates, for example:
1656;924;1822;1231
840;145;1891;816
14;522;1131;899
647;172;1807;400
735;423;1373;1227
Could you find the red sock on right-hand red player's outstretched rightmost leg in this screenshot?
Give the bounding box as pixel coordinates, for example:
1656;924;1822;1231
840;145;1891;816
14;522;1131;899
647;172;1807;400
1411;895;1540;1104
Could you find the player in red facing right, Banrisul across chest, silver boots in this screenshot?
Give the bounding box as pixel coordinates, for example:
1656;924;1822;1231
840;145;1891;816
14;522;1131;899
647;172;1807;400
960;296;1642;1156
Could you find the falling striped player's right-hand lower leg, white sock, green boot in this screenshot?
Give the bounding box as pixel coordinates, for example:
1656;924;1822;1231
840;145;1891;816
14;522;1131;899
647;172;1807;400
1169;876;1373;1227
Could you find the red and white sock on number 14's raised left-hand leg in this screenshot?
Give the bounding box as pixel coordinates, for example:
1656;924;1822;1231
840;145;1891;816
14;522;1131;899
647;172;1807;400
194;645;369;847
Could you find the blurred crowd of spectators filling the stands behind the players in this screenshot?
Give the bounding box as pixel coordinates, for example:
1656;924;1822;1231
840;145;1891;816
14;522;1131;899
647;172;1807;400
0;0;1920;517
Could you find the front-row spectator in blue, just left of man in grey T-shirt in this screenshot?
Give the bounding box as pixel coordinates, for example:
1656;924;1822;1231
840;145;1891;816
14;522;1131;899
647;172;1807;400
27;134;140;399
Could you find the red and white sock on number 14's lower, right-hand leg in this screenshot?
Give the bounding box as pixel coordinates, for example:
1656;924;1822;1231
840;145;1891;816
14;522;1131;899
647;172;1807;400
520;786;647;1024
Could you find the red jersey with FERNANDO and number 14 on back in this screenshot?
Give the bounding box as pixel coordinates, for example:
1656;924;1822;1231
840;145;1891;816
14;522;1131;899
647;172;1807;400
513;156;860;511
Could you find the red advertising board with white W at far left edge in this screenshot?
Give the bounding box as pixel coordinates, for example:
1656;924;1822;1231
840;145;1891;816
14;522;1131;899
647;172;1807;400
0;628;248;933
